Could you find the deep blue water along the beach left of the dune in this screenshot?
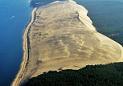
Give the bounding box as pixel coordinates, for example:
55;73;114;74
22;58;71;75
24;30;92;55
0;0;32;86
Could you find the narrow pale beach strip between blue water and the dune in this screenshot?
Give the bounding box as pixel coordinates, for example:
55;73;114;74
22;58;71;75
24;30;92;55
11;8;37;86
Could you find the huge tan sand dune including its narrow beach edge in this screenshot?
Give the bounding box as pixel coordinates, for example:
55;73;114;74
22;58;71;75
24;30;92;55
13;0;123;86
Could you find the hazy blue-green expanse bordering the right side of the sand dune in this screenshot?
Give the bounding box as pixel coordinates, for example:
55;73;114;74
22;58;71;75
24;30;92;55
77;0;123;45
